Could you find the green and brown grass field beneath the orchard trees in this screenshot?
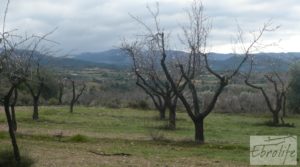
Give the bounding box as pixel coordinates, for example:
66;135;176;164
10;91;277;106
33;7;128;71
0;107;300;167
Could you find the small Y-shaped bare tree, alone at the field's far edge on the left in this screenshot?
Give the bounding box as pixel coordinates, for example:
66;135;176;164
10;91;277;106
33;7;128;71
69;78;86;113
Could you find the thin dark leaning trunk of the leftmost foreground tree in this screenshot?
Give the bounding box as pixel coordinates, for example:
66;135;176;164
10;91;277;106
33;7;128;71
4;97;21;163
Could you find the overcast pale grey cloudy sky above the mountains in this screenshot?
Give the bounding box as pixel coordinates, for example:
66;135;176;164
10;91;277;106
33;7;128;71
0;0;300;54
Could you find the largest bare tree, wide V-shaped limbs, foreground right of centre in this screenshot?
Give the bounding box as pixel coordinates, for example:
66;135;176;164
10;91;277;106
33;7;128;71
123;0;269;143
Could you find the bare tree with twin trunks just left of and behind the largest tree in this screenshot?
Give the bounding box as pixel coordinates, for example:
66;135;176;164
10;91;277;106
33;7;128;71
122;3;191;129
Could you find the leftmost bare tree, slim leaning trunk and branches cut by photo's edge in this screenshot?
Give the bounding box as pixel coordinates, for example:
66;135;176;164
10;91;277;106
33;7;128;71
0;0;55;163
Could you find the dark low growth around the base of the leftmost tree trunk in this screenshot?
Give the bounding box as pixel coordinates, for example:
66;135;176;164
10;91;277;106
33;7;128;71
0;150;34;167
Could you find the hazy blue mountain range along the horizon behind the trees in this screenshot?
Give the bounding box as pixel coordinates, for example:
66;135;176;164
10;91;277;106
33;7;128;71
0;48;300;71
